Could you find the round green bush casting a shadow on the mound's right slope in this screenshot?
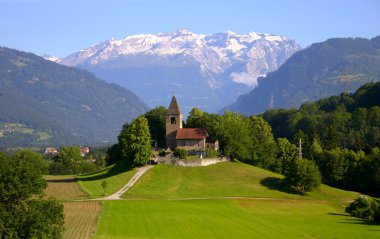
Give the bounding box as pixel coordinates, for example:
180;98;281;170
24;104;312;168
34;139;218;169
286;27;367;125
284;159;321;193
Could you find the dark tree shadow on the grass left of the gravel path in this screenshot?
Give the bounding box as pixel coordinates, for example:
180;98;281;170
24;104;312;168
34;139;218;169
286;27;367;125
77;161;133;181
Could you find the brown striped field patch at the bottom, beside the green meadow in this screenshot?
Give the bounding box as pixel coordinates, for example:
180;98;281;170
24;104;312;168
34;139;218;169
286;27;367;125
63;202;102;239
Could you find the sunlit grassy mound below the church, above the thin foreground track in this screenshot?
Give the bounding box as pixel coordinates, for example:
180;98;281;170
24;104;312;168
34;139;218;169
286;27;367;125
123;162;357;205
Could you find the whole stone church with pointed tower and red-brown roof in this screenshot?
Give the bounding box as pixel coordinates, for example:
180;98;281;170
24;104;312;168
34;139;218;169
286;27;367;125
166;96;219;152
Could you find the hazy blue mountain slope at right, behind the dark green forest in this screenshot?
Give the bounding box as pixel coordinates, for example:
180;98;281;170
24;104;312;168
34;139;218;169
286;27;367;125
225;36;380;115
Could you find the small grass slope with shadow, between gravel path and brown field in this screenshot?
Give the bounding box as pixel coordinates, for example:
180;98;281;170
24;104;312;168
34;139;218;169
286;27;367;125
77;162;136;198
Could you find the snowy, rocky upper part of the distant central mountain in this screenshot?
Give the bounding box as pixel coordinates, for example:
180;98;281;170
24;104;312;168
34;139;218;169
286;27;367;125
57;29;300;86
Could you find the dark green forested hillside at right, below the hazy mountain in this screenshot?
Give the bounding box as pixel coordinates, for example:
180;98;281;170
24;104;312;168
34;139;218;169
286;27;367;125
262;82;380;196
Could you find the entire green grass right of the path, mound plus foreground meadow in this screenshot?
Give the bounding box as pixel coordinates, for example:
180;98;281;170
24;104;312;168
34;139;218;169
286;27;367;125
88;162;380;238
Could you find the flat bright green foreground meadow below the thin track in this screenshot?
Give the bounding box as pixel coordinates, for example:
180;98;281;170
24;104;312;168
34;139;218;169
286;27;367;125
94;199;380;239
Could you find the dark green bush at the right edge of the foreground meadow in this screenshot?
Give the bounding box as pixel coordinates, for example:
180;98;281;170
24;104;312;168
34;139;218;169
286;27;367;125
346;196;380;221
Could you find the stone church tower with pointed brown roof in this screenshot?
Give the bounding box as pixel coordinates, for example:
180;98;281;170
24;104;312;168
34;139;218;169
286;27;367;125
165;96;182;150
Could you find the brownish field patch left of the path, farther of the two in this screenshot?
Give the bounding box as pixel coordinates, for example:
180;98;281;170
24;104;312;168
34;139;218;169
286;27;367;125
44;175;87;201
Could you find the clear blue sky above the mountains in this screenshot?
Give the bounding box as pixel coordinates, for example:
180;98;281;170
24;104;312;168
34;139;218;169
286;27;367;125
0;0;380;57
